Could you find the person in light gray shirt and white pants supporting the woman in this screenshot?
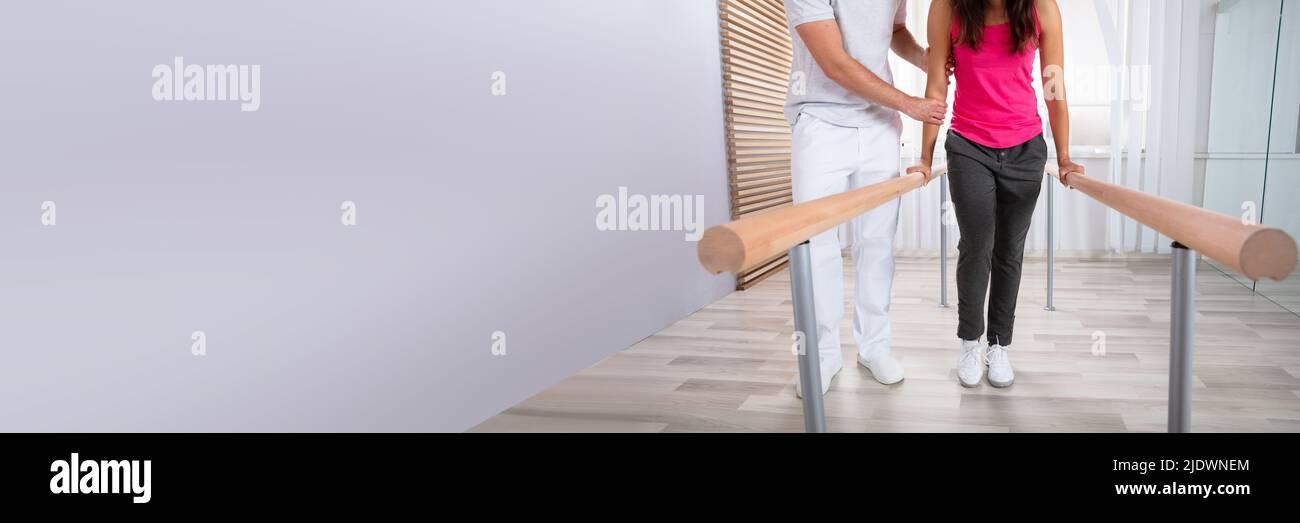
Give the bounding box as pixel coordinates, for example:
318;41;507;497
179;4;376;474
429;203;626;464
785;0;948;396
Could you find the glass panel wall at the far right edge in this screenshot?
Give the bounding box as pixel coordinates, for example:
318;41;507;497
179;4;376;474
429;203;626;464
1197;0;1300;314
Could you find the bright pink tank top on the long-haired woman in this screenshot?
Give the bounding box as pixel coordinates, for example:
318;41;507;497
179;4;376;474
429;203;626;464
952;8;1043;148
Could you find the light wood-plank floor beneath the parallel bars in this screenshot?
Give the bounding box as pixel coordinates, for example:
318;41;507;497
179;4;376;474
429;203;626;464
472;258;1300;432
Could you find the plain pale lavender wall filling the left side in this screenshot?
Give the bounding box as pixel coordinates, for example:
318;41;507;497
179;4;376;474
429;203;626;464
0;0;732;431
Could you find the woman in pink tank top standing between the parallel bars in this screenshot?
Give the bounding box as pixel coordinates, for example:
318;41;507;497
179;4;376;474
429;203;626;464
907;0;1083;386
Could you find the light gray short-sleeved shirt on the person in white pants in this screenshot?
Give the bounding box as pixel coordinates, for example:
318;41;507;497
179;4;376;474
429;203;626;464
785;0;907;127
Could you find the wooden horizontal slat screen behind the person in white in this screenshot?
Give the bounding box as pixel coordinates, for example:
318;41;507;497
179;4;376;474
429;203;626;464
718;0;793;290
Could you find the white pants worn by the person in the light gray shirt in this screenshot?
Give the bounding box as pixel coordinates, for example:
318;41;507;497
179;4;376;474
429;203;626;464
790;114;902;363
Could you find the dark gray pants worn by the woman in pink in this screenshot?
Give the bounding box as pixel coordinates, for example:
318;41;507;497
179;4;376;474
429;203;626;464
944;131;1048;346
